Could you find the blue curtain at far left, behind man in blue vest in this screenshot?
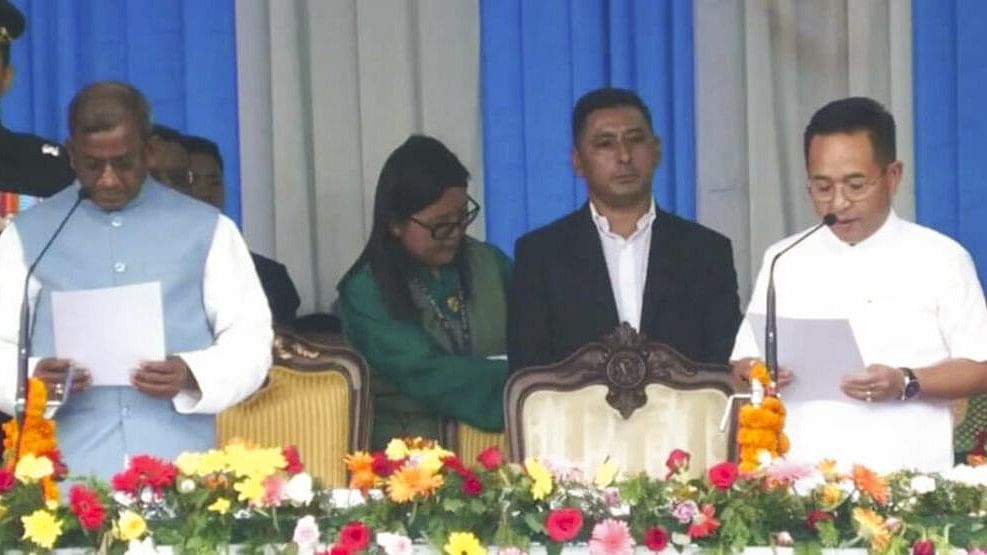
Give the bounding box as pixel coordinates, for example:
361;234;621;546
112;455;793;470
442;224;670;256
0;0;240;223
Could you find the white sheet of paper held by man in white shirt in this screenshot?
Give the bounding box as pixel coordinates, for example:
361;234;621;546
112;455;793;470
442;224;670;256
747;314;864;402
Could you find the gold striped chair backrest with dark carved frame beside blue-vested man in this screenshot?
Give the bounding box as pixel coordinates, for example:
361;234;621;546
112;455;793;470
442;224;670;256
217;332;371;487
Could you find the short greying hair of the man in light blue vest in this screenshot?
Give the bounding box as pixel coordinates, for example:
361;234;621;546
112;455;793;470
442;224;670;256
69;81;151;141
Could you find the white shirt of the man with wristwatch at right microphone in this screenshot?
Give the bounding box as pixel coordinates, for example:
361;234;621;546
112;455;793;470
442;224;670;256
730;212;987;472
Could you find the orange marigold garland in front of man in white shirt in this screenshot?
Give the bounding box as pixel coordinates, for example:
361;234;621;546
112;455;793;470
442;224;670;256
737;362;789;472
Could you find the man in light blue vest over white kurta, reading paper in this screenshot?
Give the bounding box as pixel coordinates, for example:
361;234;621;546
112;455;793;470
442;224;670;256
0;82;272;477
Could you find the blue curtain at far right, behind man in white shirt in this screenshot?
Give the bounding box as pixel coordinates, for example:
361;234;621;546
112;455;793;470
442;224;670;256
912;0;987;283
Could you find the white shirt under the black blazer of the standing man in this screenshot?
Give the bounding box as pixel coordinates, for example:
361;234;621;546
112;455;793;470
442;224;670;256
589;202;657;330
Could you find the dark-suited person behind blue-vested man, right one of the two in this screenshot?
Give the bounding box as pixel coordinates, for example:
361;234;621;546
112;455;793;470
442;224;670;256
176;135;301;326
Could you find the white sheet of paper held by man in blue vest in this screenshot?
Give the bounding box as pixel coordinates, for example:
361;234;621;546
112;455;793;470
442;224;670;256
51;281;165;385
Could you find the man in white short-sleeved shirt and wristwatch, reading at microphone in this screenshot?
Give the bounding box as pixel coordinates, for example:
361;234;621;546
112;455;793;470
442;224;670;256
731;99;987;471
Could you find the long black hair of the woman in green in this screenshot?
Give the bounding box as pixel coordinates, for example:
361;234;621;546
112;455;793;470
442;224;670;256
339;135;470;320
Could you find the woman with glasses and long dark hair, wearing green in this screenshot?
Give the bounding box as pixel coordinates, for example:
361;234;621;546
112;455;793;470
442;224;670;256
339;135;511;455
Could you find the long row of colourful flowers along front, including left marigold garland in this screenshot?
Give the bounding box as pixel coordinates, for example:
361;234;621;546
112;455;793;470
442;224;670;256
0;382;987;555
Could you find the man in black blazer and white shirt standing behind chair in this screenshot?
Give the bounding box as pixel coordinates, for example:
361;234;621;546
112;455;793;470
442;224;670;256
508;89;740;369
